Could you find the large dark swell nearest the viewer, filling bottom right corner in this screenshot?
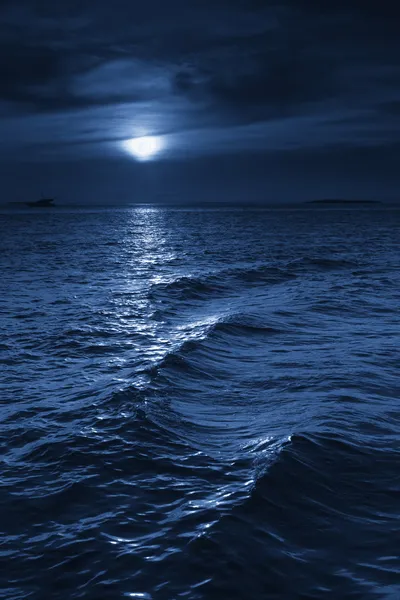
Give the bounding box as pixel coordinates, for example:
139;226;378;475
181;434;400;600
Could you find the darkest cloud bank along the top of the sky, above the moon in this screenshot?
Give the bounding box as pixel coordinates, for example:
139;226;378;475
0;0;399;118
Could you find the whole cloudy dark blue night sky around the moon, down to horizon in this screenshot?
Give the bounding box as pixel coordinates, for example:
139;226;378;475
0;0;400;204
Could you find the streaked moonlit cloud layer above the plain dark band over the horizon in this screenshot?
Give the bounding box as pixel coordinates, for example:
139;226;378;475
0;0;400;202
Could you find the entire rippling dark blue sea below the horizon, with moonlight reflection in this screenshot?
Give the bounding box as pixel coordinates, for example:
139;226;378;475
0;207;400;600
